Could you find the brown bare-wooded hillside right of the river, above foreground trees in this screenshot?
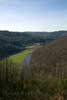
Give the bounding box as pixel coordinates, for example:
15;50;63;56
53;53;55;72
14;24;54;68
31;37;67;68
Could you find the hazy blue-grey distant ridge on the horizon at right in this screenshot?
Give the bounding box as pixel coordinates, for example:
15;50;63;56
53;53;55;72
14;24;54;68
25;31;67;39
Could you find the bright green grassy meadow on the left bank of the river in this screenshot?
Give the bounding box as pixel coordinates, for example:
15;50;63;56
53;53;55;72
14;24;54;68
9;49;32;64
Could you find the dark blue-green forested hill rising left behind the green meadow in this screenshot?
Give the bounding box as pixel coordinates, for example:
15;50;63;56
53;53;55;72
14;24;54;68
0;31;45;57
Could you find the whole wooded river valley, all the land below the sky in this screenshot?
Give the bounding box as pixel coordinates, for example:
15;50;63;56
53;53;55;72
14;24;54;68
0;31;67;100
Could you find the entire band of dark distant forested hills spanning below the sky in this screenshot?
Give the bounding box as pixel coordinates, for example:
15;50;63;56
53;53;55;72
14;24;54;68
0;31;67;57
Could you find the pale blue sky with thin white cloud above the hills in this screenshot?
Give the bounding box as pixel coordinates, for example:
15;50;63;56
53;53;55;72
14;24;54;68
0;0;67;31
